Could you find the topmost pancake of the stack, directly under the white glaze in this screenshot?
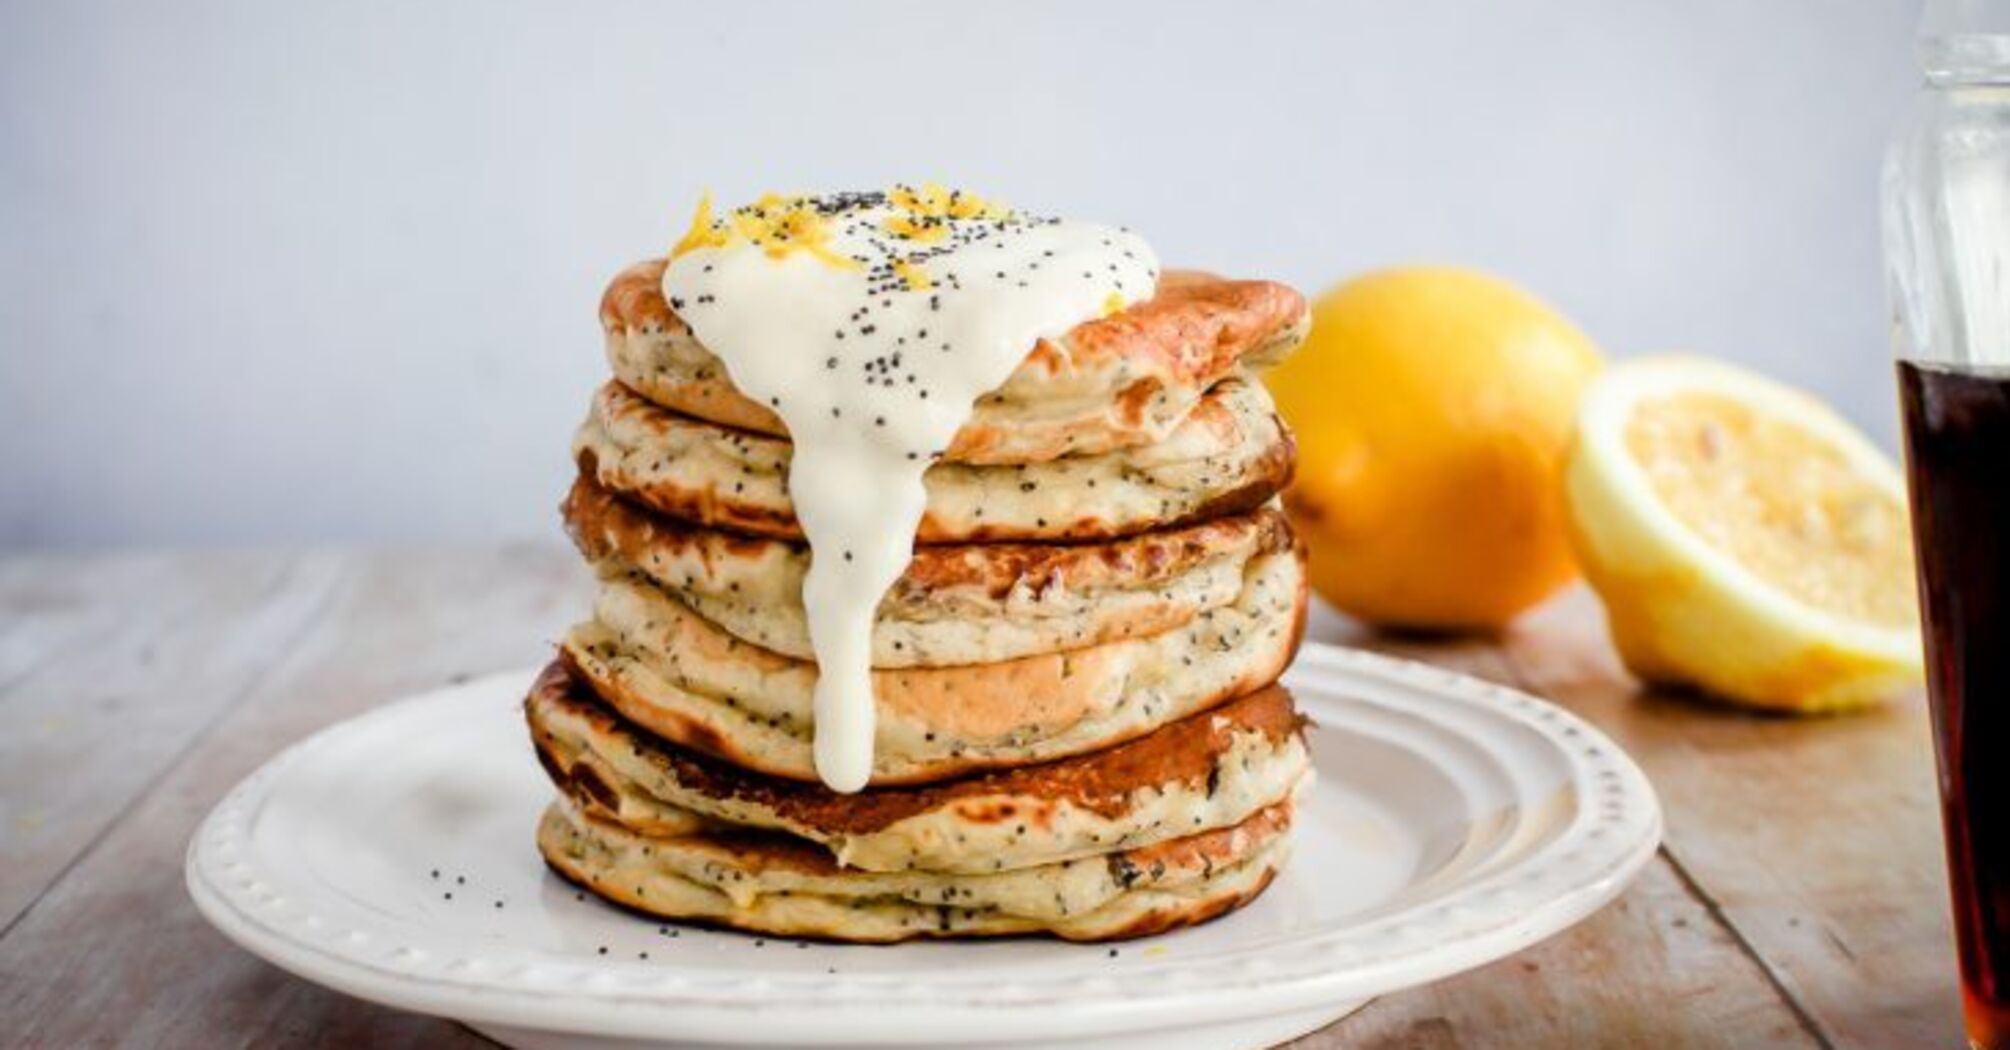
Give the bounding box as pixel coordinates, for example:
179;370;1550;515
601;259;1309;465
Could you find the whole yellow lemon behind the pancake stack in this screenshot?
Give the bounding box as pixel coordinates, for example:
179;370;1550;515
1266;268;1600;630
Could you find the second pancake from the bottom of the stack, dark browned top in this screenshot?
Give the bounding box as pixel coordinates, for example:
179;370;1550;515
525;664;1311;875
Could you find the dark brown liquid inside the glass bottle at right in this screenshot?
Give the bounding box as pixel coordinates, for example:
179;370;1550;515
1897;362;2010;1048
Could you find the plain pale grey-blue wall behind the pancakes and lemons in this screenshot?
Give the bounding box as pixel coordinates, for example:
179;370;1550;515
0;0;1916;547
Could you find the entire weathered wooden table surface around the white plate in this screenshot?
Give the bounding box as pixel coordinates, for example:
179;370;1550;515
0;545;1962;1050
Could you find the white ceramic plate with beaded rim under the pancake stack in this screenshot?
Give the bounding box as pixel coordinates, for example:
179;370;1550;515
187;646;1660;1050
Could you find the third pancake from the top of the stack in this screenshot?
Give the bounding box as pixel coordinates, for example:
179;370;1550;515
563;477;1294;668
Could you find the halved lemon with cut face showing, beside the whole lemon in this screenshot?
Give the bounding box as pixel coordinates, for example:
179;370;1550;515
1564;358;1922;712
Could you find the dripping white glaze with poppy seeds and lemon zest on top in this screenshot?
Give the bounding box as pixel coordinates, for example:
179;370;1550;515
663;187;1158;793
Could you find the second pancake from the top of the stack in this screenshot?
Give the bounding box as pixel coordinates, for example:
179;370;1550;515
573;380;1294;543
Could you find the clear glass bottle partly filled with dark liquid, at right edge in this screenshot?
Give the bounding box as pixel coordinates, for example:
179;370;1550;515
1883;0;2010;1050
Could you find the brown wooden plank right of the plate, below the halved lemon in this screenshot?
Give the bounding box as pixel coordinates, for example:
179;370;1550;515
1501;591;1964;1050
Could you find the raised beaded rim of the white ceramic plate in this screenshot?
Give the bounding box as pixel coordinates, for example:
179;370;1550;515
185;642;1662;1042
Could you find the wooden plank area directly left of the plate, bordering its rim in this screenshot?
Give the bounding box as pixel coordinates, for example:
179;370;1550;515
0;547;587;1048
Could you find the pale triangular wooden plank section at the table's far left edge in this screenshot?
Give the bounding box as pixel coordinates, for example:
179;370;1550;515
0;553;334;929
